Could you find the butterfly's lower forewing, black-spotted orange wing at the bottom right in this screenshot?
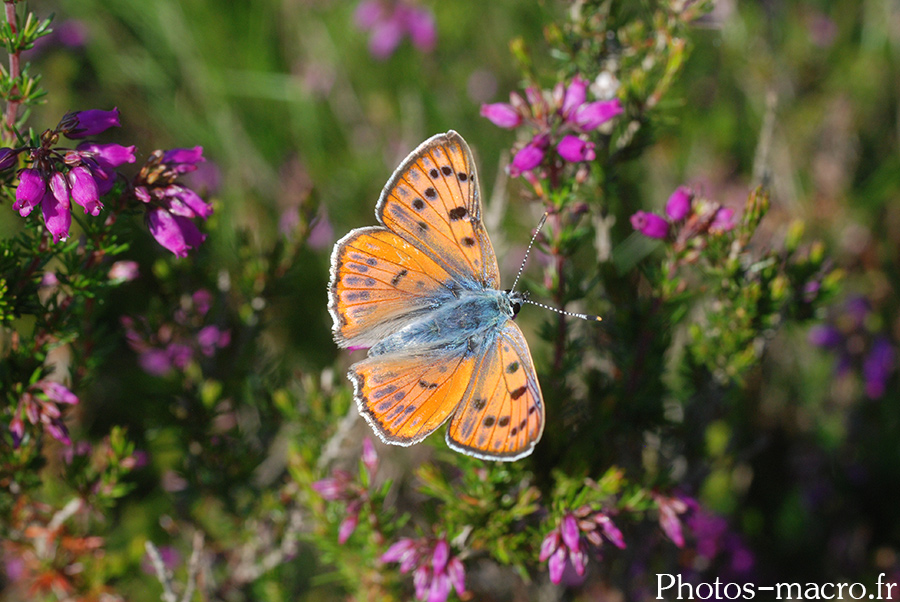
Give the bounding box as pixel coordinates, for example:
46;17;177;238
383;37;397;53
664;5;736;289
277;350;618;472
447;321;544;461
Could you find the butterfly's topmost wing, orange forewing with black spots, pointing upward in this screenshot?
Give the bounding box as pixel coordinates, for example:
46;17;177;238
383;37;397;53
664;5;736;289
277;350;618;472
375;131;500;288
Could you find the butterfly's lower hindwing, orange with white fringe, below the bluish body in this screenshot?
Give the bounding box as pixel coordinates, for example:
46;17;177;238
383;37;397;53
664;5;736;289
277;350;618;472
349;352;476;445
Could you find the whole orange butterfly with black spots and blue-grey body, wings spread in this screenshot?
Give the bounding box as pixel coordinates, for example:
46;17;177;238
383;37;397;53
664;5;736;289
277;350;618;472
328;131;544;461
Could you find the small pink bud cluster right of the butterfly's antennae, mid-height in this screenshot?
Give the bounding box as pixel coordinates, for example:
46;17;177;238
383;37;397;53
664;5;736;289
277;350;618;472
631;186;736;239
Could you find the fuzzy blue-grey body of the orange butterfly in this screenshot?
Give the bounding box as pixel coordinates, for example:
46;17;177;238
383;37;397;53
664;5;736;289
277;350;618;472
369;288;520;357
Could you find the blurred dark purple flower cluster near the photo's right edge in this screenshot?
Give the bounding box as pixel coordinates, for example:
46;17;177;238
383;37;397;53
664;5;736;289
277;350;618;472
809;297;897;399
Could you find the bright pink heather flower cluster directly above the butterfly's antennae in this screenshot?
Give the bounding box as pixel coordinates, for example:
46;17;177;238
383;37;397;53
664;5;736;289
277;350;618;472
481;76;623;177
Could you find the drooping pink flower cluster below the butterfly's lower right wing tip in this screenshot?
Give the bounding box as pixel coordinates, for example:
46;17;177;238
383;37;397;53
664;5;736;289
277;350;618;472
538;506;625;584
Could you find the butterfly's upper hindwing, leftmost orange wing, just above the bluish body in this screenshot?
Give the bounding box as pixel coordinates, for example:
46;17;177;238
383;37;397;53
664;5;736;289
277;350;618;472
328;227;452;347
